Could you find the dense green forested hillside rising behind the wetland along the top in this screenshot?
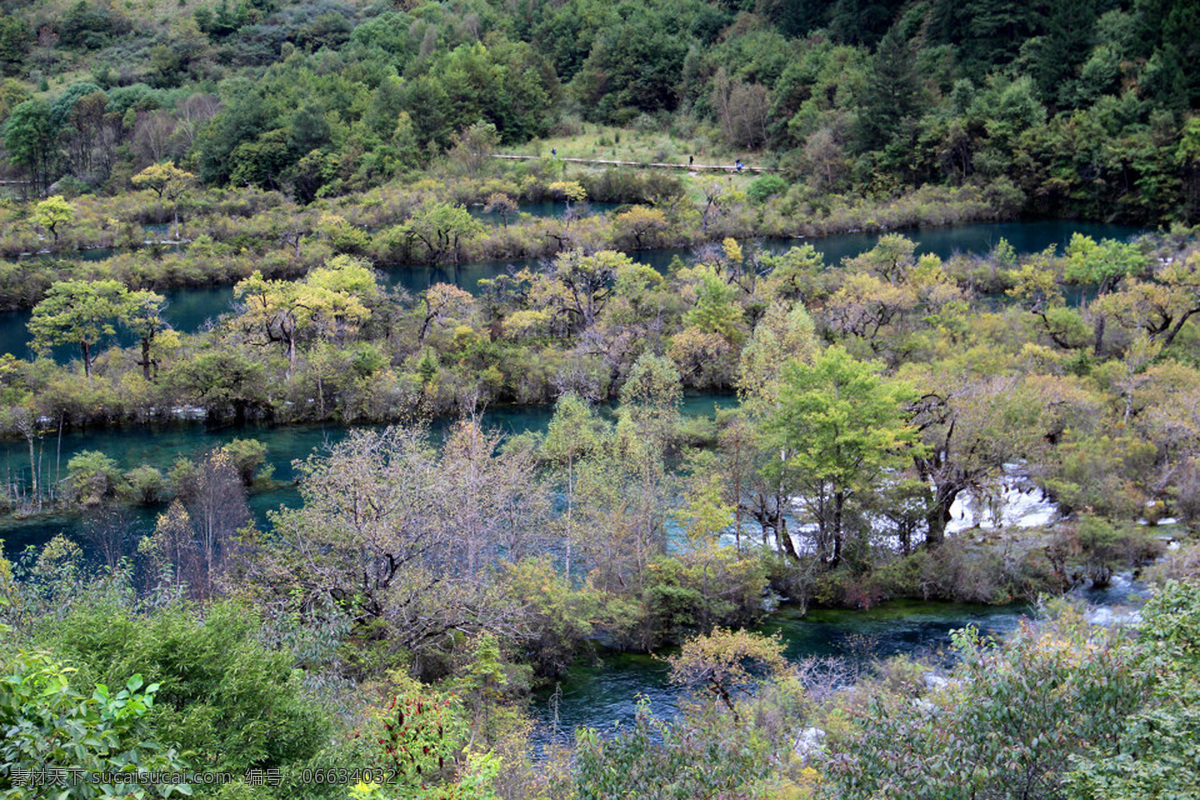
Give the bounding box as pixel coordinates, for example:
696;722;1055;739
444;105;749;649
0;0;1200;222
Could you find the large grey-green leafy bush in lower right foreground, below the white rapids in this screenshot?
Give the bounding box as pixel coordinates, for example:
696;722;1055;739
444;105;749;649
822;619;1147;800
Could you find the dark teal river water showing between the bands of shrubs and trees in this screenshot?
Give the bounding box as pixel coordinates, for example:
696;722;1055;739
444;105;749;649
0;217;1141;744
